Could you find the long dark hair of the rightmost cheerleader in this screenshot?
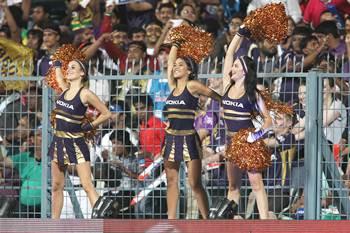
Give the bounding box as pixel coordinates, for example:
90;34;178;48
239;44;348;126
241;56;259;103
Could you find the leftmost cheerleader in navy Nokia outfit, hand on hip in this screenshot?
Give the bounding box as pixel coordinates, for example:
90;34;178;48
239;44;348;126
49;60;111;219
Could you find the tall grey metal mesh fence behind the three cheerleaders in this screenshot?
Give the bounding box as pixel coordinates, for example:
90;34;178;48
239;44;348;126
0;55;350;219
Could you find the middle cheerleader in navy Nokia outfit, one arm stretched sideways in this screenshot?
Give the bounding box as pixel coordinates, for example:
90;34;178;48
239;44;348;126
162;43;221;219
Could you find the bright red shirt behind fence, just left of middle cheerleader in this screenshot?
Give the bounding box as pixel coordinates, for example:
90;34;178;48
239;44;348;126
139;116;165;166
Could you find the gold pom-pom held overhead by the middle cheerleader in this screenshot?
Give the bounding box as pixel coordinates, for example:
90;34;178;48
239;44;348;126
169;24;213;63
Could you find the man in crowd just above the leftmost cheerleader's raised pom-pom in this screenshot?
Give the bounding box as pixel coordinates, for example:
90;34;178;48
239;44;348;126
38;24;61;76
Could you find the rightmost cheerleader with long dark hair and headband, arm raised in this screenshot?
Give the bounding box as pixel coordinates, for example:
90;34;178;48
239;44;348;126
222;26;272;219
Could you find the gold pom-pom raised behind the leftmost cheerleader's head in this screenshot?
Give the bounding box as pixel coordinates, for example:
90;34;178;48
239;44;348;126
45;44;85;94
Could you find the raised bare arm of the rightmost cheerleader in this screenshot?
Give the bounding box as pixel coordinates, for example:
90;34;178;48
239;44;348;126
223;25;250;90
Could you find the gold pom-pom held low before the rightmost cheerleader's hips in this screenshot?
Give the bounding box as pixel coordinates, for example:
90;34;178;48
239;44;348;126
225;128;271;171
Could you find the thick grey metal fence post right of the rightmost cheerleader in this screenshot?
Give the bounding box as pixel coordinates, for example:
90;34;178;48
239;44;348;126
304;70;322;220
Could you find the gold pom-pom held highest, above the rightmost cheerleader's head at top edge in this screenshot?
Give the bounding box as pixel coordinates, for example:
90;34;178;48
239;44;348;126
243;3;288;43
